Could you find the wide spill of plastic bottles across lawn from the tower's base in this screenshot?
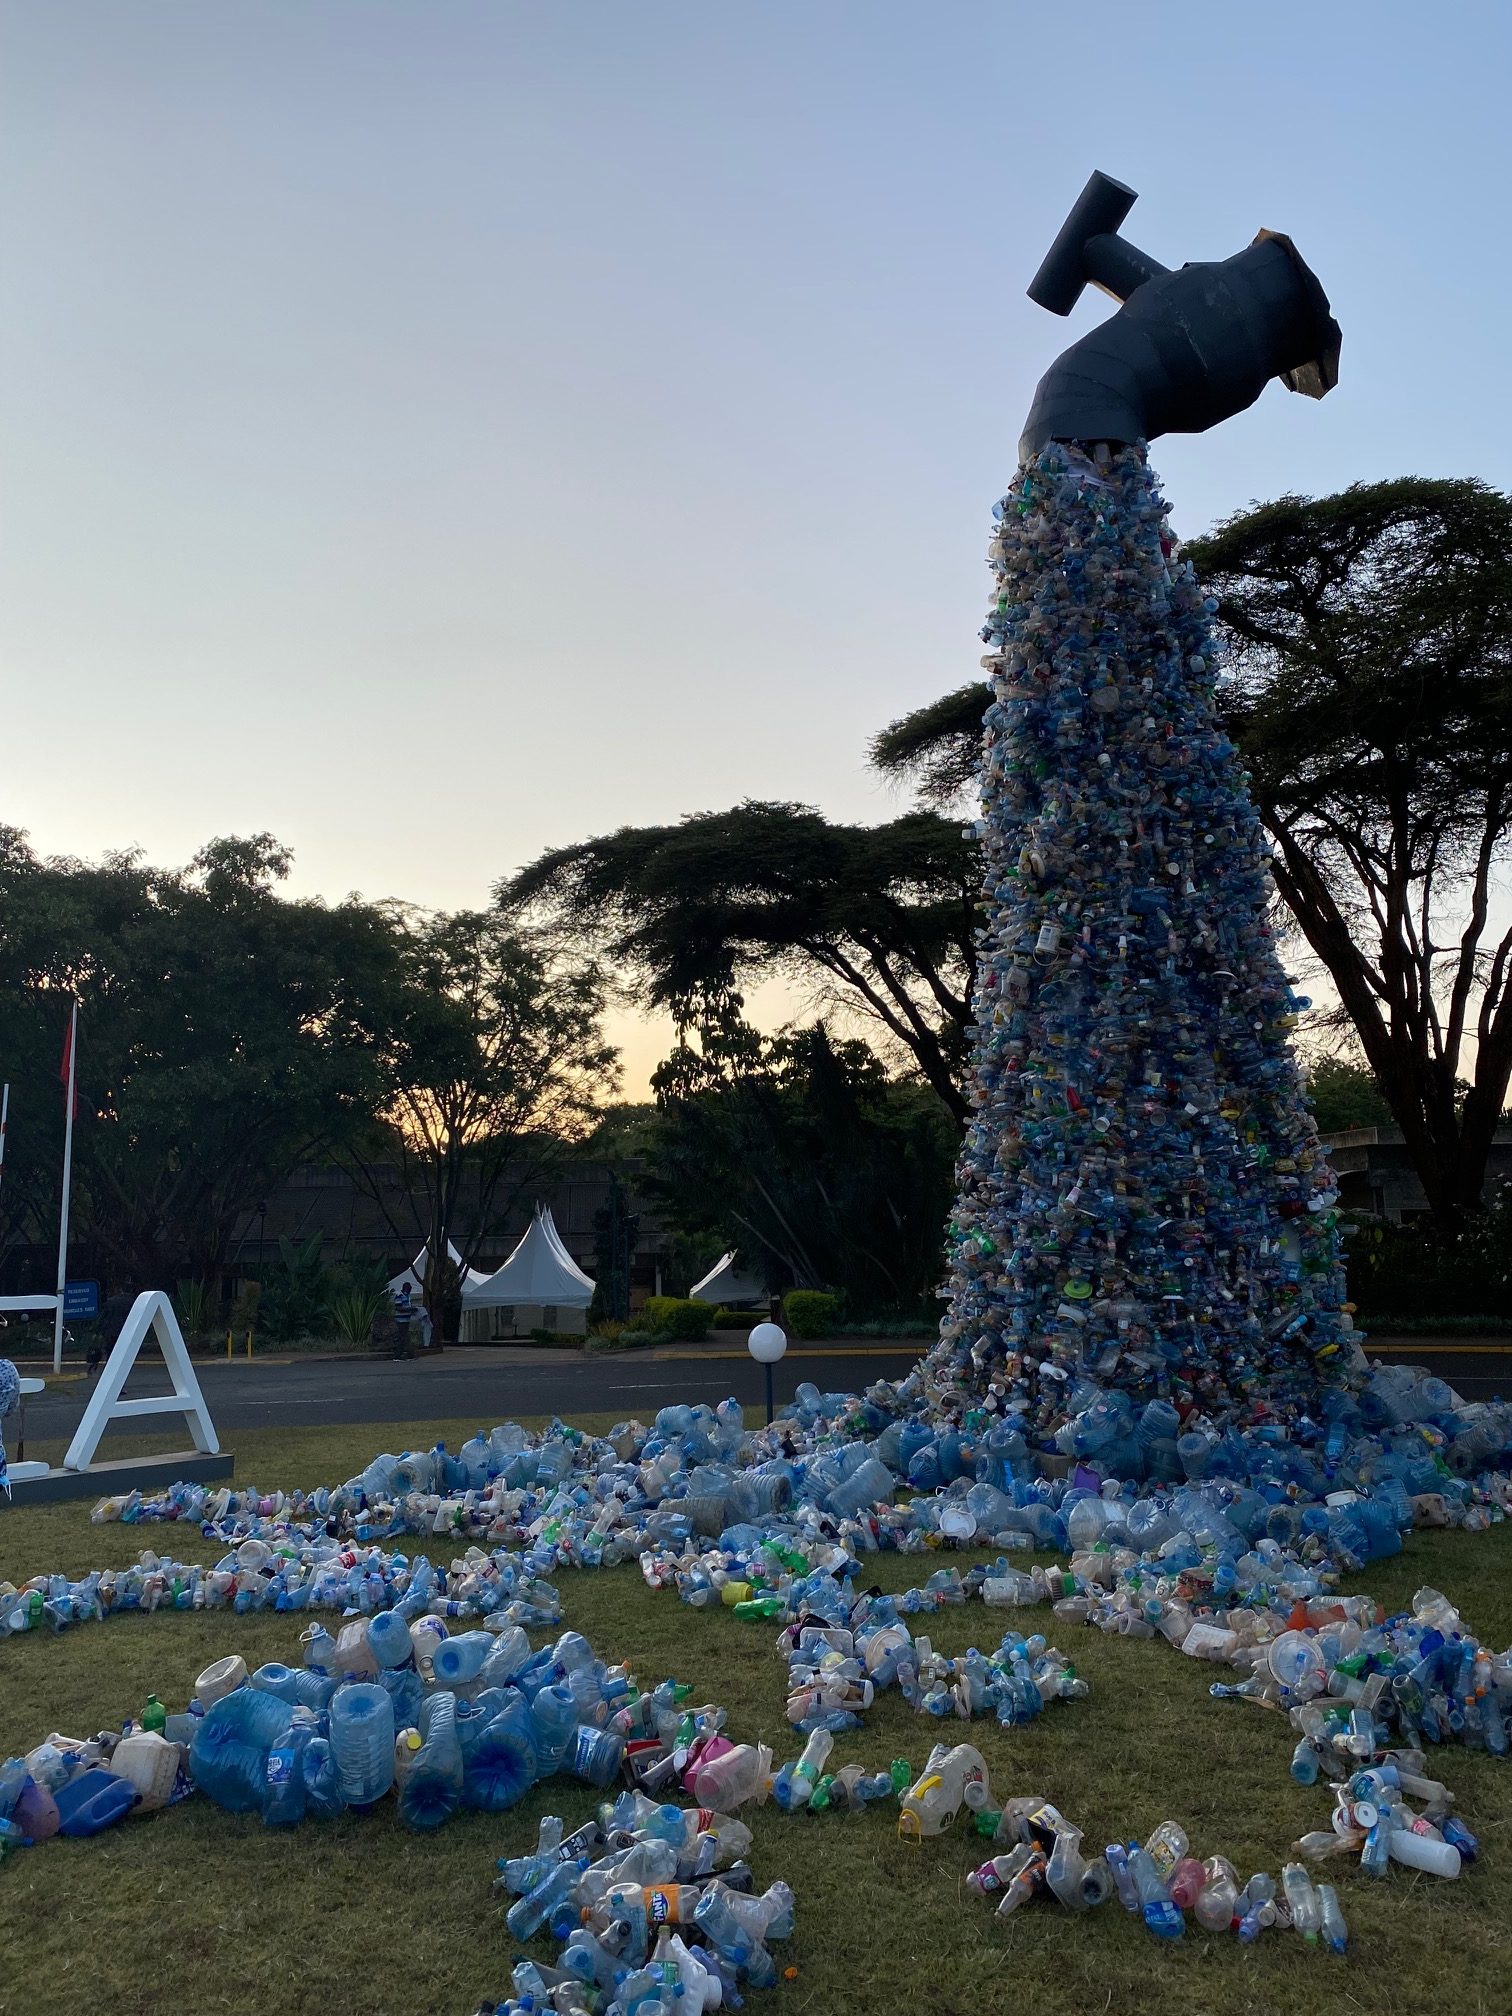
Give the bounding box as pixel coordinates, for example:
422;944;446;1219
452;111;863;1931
0;1367;1512;1998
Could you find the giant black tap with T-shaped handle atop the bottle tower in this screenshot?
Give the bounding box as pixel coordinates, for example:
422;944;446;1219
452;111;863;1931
1018;173;1339;462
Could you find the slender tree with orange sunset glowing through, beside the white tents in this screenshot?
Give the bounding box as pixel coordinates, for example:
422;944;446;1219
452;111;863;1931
357;911;617;1329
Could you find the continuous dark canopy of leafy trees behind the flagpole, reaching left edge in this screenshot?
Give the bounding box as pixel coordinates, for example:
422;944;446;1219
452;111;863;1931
0;829;613;1288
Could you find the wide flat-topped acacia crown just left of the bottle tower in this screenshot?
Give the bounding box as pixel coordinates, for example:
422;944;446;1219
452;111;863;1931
496;800;978;1119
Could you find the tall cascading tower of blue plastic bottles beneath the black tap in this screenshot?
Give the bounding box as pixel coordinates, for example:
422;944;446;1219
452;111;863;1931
927;442;1347;1431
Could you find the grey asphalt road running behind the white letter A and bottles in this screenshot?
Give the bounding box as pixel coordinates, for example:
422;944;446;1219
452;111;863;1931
14;1337;1512;1441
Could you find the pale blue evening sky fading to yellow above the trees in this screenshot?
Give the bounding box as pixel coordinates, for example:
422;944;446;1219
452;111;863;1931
0;0;1512;1091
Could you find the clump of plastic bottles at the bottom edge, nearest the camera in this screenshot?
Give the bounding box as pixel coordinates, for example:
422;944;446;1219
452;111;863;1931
481;1792;794;2016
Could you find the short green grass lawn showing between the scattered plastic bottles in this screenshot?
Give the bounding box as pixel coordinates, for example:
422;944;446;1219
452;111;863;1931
0;1415;1512;2016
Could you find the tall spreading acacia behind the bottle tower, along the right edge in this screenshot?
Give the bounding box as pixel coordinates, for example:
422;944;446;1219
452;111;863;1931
873;478;1512;1232
